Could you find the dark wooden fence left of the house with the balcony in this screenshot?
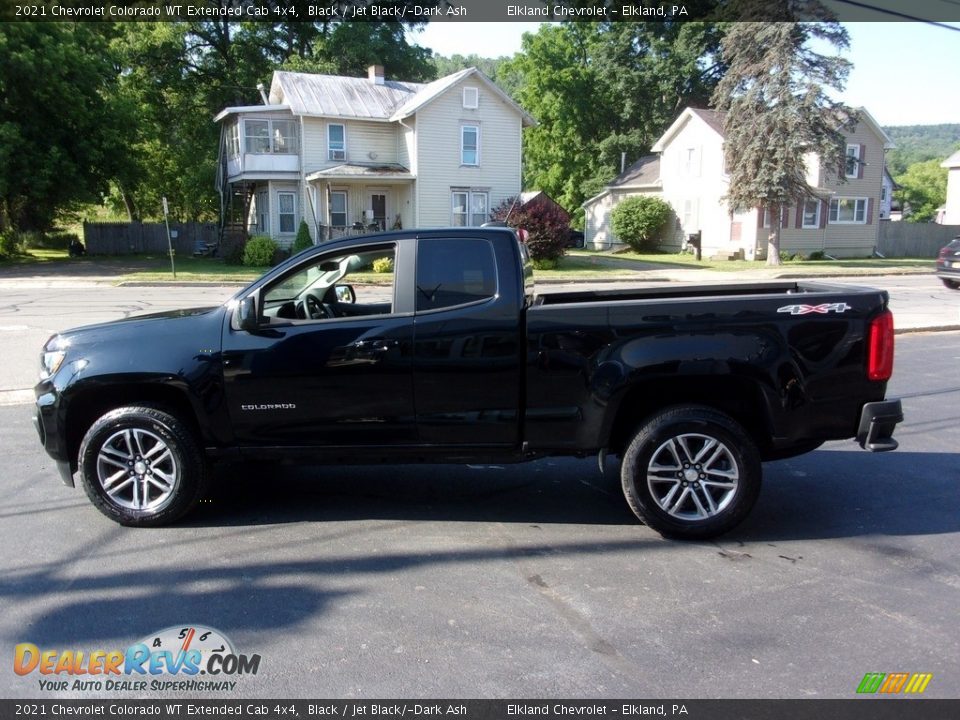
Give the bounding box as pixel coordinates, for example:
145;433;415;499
83;222;218;256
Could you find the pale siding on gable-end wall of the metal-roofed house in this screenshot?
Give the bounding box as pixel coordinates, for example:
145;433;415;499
414;78;521;227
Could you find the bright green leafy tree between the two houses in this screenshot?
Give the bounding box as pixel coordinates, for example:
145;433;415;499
506;21;726;224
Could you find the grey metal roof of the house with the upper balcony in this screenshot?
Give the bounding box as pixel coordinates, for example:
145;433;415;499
258;67;536;126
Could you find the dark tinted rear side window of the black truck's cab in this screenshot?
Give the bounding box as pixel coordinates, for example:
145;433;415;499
417;238;497;312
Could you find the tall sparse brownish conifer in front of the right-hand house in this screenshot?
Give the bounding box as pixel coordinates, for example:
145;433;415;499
713;14;856;265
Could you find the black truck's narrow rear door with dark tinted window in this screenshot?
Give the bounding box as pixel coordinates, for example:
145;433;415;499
413;234;522;446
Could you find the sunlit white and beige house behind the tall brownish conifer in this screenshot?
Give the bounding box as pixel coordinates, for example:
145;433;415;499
583;108;893;259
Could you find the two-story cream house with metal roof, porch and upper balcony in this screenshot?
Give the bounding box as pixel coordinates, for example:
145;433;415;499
215;65;535;246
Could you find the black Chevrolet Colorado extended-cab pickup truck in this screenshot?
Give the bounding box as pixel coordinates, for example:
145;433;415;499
36;228;902;538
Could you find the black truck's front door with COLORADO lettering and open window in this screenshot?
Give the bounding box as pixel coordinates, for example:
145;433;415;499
223;242;417;448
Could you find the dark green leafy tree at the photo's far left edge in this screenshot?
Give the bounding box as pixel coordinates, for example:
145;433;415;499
0;23;128;232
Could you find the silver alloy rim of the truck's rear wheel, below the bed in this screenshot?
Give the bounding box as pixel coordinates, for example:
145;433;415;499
647;433;740;522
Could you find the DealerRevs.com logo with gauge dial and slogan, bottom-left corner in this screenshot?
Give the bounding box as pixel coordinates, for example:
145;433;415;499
13;625;260;692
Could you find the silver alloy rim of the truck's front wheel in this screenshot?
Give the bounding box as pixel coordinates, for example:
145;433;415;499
97;428;180;512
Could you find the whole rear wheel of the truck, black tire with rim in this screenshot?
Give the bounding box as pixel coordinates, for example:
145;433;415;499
620;405;762;540
